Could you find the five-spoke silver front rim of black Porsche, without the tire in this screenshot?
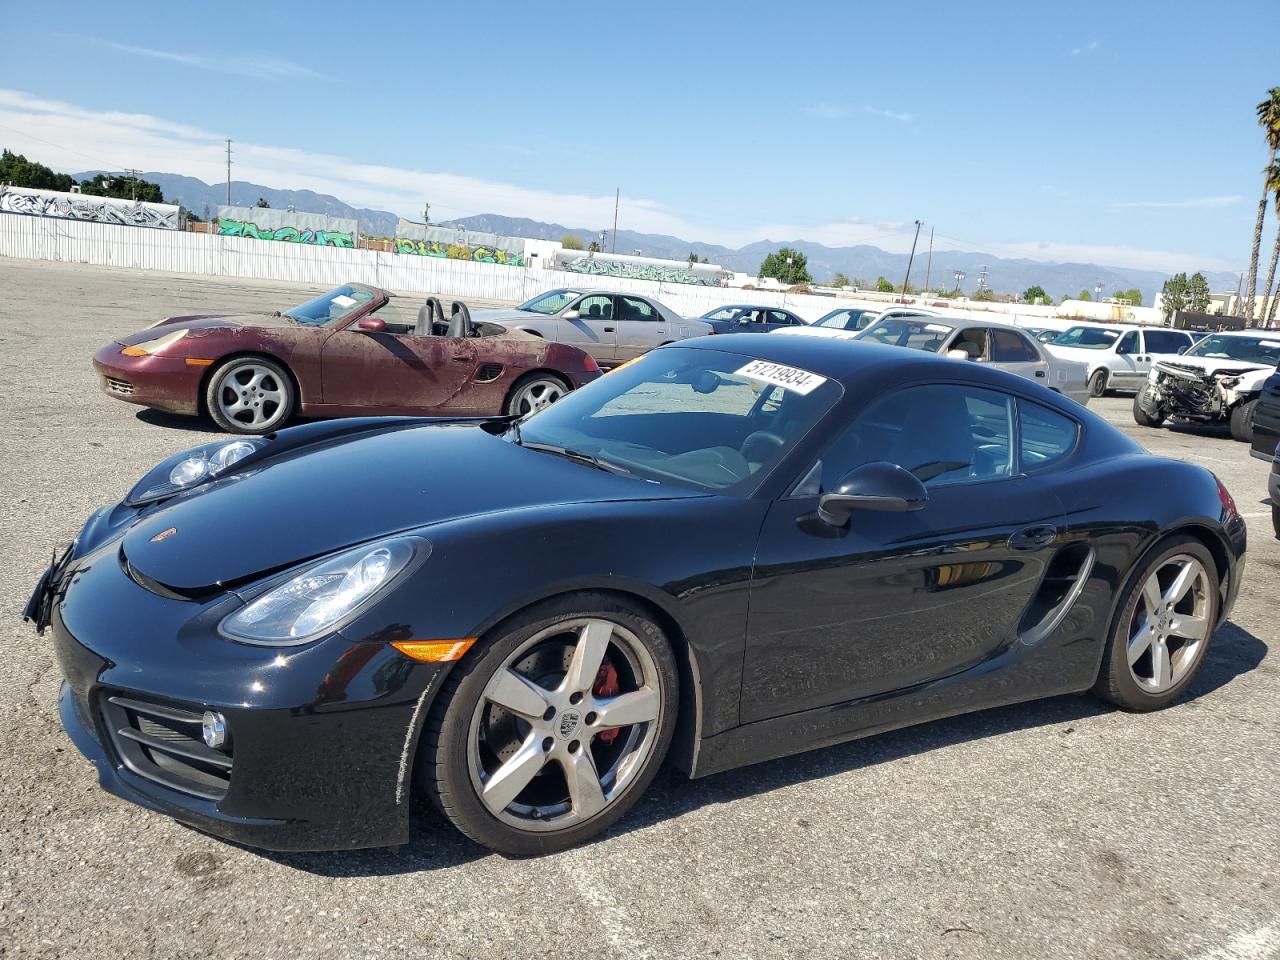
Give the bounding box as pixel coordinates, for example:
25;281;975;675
467;617;663;832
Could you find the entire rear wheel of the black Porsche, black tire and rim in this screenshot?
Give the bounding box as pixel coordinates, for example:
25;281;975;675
1093;535;1221;713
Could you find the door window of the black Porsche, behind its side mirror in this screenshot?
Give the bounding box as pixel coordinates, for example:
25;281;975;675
822;384;1014;490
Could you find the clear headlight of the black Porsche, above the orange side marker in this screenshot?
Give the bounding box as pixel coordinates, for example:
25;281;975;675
220;536;430;646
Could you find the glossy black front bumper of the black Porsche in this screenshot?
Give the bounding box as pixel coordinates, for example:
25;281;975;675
50;543;444;850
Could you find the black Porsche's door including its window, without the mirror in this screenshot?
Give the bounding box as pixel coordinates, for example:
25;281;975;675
741;384;1065;722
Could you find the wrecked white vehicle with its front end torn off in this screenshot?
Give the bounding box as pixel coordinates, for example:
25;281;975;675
1133;330;1280;443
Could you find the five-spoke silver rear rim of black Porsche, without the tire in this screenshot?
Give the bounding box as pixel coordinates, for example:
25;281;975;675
1129;554;1212;694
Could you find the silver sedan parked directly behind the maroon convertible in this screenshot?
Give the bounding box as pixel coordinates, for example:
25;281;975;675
474;288;712;367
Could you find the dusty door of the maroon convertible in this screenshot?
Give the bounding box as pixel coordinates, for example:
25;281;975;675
320;326;476;413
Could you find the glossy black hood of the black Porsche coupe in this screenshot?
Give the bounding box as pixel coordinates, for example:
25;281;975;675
123;421;703;595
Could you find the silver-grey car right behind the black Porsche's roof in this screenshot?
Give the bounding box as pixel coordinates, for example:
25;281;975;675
849;316;1089;404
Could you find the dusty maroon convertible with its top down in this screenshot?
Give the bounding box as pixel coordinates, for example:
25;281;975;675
93;283;600;434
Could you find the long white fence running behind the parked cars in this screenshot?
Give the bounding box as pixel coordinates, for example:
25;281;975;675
0;214;1090;323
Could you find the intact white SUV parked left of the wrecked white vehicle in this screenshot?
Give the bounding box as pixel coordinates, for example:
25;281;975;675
1044;324;1194;397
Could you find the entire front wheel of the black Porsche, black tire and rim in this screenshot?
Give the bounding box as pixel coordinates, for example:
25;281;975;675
416;593;680;856
